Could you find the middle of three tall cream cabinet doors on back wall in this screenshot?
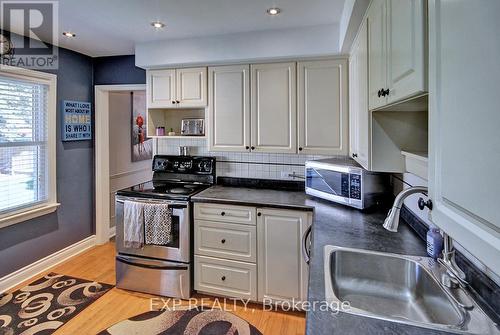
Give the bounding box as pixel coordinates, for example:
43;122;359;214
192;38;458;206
251;63;297;153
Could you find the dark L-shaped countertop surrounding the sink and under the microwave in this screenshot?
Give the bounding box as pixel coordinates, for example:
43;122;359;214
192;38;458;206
192;185;458;335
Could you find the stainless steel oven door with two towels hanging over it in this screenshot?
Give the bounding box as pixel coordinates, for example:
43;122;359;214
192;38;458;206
115;196;190;263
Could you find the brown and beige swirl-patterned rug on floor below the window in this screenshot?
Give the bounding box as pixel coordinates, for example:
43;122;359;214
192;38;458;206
0;273;113;335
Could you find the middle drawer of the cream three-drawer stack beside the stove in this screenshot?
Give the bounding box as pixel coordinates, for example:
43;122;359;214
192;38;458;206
194;220;257;263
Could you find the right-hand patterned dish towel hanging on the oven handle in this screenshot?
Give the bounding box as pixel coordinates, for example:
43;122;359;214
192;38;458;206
144;204;172;245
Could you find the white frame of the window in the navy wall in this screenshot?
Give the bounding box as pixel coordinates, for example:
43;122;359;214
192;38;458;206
0;65;60;228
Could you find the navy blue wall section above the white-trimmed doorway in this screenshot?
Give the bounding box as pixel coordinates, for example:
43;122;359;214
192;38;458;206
94;55;146;85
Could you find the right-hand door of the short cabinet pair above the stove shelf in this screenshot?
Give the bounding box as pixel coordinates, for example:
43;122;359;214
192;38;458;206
176;67;207;107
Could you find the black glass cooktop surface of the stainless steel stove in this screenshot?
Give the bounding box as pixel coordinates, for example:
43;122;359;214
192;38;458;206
116;181;211;201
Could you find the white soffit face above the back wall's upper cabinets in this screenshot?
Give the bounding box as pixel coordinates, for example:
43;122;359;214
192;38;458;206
135;24;339;68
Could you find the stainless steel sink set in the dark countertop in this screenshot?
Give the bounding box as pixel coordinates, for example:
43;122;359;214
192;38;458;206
324;245;500;334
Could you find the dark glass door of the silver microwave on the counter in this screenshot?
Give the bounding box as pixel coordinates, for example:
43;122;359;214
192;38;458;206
306;165;350;204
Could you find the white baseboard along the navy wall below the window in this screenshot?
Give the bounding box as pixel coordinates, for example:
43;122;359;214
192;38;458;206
0;235;96;293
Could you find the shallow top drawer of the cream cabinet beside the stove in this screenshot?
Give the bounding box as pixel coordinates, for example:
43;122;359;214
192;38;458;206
194;203;256;225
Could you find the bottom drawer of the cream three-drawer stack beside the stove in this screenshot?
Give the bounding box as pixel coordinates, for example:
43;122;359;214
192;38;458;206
194;256;257;301
